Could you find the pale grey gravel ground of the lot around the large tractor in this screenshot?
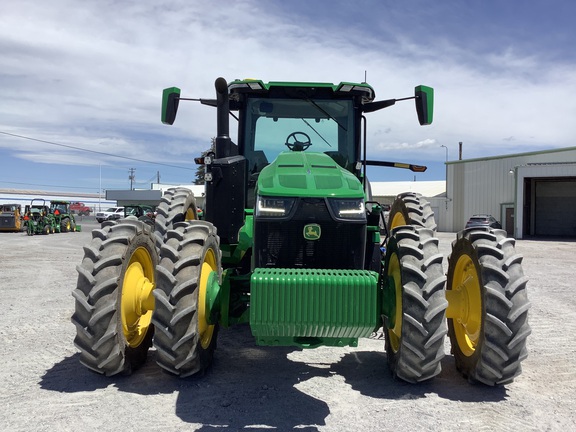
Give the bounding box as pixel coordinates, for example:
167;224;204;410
0;218;576;431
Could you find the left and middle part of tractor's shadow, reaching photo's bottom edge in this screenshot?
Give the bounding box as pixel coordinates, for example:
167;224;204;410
39;326;330;432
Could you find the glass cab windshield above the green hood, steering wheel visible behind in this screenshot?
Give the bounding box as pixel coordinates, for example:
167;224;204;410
244;98;356;174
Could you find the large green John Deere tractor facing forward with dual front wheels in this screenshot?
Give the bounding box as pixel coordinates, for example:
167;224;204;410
72;78;530;385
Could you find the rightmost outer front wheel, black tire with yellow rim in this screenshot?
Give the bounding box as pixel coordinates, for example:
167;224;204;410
446;228;531;386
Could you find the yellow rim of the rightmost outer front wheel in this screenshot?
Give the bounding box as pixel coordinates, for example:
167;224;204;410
447;255;482;356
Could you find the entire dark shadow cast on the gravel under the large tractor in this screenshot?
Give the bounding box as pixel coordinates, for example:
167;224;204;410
40;325;507;431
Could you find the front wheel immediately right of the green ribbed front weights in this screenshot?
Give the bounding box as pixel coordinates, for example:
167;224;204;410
384;226;448;383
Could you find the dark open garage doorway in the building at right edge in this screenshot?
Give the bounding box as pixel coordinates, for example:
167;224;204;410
534;180;576;237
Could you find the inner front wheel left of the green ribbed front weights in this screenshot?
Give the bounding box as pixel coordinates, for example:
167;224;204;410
153;221;221;377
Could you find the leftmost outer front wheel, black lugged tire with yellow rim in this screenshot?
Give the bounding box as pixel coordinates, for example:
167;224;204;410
72;221;158;376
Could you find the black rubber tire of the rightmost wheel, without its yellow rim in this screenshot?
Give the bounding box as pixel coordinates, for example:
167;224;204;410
448;229;531;386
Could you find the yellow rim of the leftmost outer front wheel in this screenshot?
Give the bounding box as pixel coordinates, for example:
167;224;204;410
121;247;155;348
